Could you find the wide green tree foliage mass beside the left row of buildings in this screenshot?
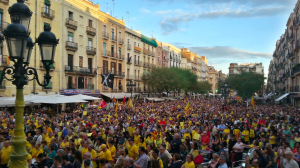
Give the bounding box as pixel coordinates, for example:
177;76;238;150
142;68;211;94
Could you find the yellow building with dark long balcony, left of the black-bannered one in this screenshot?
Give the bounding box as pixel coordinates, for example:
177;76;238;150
60;0;100;94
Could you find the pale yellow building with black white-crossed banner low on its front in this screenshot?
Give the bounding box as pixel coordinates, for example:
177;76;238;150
98;11;126;93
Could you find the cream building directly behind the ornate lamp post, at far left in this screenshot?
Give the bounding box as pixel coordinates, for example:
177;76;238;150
0;0;62;96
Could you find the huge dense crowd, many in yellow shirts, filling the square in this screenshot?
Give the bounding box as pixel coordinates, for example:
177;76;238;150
0;98;300;168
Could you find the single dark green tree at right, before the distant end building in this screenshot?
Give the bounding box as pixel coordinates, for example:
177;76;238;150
227;72;265;100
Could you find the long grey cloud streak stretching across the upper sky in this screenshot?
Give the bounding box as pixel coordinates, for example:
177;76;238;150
156;6;289;35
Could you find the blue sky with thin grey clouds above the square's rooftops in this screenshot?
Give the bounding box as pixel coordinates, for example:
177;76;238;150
94;0;297;75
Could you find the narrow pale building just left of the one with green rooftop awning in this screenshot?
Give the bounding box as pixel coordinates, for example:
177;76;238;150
125;28;143;93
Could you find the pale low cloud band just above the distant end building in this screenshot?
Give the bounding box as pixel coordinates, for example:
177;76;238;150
189;46;272;62
